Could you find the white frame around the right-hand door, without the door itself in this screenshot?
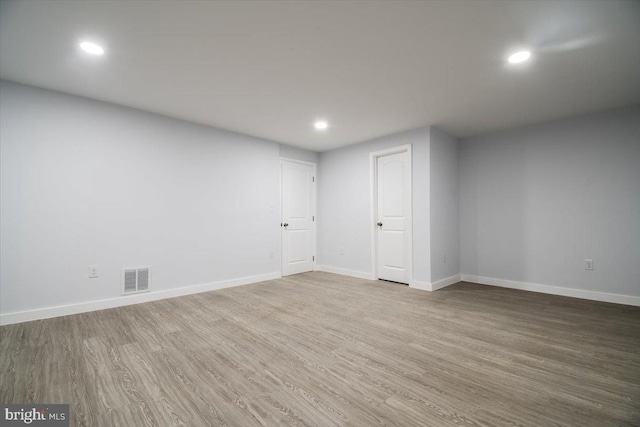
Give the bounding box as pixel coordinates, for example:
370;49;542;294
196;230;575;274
369;144;413;286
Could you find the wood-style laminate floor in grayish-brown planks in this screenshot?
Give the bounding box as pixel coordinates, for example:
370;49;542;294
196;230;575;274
0;273;640;427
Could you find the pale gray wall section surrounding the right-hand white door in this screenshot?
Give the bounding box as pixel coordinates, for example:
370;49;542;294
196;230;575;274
318;128;431;282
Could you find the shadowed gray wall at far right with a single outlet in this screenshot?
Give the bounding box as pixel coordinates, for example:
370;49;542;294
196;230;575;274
460;107;640;296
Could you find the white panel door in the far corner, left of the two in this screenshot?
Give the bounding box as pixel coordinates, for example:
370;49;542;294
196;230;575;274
281;160;315;276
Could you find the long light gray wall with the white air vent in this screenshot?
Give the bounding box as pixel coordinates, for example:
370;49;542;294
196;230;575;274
0;82;280;313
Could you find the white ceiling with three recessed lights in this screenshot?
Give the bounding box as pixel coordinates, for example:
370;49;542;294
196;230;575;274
0;0;640;151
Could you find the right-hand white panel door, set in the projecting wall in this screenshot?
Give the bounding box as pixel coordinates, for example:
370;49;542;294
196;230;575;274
376;151;411;284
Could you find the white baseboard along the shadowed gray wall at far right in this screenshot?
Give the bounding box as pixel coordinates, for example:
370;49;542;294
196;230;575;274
462;274;640;306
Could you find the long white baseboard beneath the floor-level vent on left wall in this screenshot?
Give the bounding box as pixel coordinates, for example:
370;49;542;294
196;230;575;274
0;271;282;325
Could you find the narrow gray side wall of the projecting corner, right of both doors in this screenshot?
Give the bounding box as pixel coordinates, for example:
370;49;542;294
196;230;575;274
430;127;460;282
